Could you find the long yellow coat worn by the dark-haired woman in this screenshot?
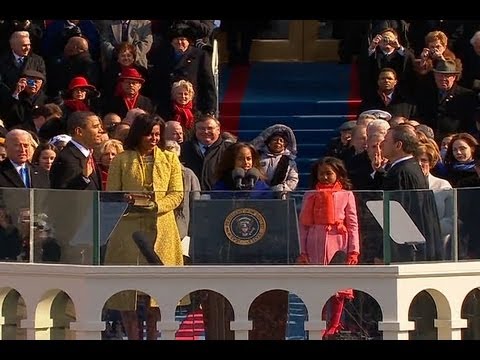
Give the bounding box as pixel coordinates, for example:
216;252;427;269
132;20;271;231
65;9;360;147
105;148;183;310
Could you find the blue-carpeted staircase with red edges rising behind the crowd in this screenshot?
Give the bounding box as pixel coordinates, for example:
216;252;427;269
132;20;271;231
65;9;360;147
219;63;359;190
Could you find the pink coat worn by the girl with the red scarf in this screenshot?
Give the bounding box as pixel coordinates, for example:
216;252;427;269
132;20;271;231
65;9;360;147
299;190;360;265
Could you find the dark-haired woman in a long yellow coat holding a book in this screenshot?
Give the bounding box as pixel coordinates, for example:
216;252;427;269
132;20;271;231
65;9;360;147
105;114;183;339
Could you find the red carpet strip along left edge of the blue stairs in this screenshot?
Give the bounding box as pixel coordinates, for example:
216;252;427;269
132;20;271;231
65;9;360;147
219;66;250;135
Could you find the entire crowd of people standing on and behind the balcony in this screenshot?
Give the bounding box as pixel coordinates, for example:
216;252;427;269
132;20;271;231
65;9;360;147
0;20;480;339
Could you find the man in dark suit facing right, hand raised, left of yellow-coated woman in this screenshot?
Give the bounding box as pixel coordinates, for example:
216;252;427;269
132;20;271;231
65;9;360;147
50;111;102;190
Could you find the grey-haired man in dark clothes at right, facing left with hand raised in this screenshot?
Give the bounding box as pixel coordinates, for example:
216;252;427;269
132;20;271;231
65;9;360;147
372;125;443;261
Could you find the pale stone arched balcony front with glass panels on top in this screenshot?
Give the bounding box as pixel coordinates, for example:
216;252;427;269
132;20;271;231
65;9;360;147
0;189;480;340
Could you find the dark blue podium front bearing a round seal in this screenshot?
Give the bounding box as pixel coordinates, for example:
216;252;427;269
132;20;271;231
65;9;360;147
189;198;299;264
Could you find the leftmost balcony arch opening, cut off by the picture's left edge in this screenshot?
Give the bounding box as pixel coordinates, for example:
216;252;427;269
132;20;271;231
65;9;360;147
0;287;27;340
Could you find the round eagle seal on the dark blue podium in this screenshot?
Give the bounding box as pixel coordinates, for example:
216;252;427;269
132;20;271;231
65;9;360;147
223;208;267;245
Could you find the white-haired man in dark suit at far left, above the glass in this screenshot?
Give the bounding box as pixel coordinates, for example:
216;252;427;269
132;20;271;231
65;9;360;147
0;129;50;189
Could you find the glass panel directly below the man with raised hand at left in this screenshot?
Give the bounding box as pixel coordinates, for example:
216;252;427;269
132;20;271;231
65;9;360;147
32;189;98;265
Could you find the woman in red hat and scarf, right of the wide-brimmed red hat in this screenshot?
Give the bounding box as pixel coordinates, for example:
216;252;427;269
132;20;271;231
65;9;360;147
104;67;155;119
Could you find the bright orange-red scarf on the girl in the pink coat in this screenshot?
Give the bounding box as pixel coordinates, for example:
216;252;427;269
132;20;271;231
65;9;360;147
300;181;347;234
